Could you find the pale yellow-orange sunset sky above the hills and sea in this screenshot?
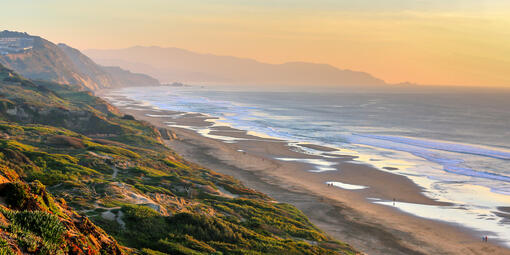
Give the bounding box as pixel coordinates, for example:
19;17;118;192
0;0;510;87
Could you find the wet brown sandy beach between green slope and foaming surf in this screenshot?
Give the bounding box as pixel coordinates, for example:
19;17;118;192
100;89;509;254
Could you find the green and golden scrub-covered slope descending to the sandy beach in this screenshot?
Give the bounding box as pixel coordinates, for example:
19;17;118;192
0;64;355;254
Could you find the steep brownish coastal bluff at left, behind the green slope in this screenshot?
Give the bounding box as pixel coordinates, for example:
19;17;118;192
0;31;159;90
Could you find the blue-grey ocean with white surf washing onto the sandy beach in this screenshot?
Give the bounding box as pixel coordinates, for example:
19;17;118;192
116;86;510;245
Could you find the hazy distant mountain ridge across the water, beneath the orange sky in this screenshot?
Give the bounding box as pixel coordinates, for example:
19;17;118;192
84;46;385;86
